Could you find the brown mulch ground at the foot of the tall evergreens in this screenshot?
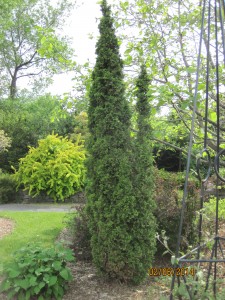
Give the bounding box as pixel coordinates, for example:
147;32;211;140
59;230;170;300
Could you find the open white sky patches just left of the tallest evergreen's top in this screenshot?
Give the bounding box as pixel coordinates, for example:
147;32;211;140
48;0;107;94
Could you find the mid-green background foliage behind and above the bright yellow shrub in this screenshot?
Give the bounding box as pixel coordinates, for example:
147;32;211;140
0;95;75;172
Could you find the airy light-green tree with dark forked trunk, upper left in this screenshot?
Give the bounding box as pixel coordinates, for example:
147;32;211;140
0;0;74;98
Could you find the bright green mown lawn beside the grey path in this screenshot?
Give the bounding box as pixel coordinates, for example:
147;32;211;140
0;212;66;271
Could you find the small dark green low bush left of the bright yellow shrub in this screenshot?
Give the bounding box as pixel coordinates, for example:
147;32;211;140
0;171;17;203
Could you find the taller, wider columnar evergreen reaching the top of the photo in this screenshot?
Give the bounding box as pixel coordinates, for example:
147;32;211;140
86;0;154;283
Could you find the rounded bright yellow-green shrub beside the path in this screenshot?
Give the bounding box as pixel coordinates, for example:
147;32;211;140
15;135;86;201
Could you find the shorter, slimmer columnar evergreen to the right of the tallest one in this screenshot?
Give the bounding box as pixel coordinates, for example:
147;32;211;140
133;65;156;277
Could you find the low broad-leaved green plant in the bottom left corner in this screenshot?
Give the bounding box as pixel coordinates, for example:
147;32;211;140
0;245;74;300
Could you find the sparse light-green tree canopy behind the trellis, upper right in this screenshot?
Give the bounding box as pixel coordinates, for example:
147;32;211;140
111;0;225;155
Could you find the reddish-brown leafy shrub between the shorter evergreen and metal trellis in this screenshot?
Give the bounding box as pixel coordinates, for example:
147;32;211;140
155;169;199;251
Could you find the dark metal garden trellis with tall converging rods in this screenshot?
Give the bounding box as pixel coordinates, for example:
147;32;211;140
170;0;225;300
